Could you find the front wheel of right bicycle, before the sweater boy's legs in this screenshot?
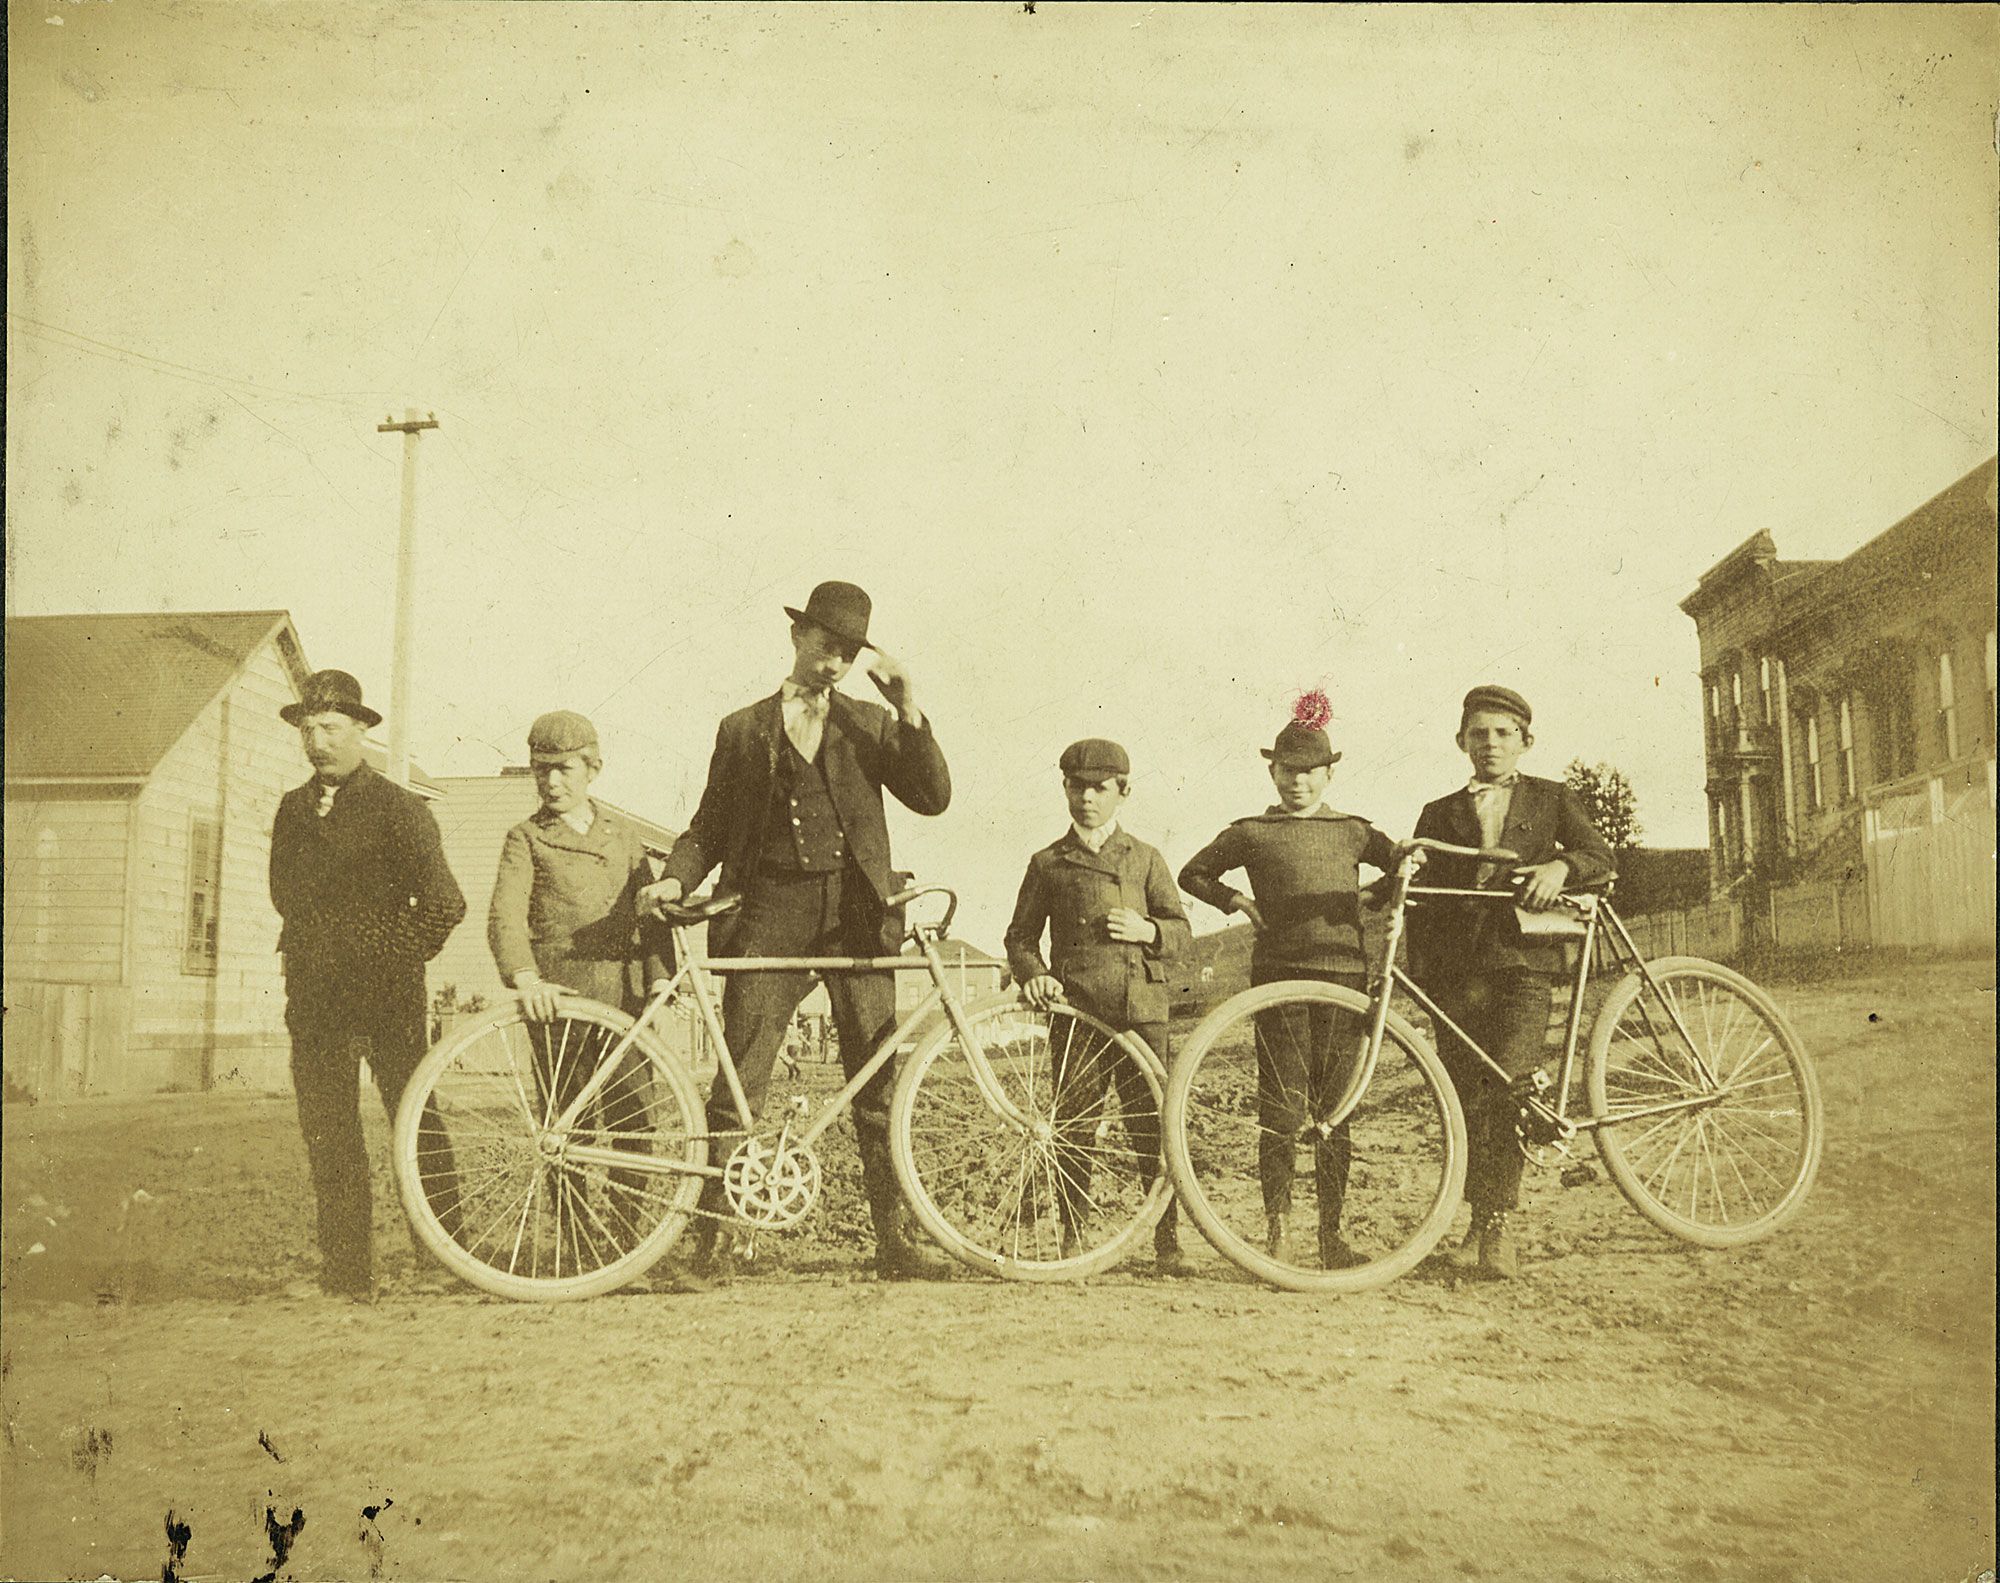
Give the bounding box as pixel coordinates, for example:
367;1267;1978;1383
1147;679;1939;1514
1166;979;1466;1291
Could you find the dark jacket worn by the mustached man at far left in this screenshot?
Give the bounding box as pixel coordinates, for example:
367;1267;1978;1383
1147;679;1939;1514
270;764;466;1003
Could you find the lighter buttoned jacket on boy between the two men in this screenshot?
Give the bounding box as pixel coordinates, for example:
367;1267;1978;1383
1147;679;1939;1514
486;803;666;1011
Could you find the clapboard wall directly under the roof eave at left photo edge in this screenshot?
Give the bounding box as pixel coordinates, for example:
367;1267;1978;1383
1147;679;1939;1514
4;795;128;983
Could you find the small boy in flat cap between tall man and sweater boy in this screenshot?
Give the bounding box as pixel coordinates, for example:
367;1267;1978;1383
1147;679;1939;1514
1006;738;1192;1275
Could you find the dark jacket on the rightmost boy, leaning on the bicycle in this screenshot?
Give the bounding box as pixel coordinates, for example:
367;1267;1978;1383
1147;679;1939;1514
1408;776;1614;983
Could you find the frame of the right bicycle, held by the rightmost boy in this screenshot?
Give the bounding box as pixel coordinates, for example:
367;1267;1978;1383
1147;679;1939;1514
1318;857;1744;1141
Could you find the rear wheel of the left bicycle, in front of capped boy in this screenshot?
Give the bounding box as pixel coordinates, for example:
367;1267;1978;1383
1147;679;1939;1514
394;995;708;1301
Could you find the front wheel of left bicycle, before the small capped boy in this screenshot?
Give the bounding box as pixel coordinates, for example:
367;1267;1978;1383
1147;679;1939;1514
890;995;1168;1281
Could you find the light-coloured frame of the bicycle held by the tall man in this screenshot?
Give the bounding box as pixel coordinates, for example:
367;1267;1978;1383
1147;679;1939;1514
536;885;1030;1175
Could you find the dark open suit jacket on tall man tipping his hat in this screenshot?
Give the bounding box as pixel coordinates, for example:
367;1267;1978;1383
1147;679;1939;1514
666;694;952;955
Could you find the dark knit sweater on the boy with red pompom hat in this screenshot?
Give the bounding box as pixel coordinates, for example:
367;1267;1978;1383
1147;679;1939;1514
1180;807;1396;971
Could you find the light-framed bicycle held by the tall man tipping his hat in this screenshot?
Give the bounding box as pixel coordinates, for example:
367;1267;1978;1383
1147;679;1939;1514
394;885;1168;1301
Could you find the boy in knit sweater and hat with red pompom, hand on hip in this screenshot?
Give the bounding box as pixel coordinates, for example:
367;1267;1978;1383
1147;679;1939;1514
1180;694;1396;1269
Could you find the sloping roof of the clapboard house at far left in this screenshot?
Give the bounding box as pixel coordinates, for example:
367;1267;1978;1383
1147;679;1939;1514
6;610;304;782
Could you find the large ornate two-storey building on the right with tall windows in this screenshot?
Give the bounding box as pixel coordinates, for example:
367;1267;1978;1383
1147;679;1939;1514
1680;460;1996;937
